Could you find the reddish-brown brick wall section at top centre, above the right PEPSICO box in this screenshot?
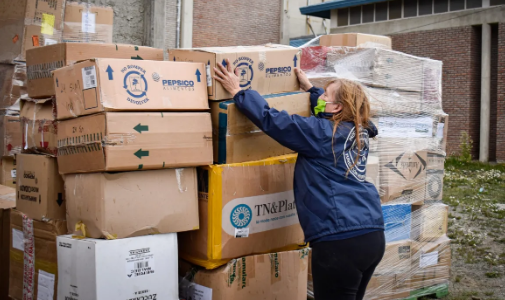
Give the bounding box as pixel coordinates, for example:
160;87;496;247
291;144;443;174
193;0;281;47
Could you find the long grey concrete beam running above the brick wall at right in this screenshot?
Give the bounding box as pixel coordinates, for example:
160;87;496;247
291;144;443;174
331;5;505;35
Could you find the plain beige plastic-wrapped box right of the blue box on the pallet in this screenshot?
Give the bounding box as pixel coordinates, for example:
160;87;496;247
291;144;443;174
412;203;449;242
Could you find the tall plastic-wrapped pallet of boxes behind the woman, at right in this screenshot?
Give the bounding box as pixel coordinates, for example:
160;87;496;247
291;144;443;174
301;34;451;299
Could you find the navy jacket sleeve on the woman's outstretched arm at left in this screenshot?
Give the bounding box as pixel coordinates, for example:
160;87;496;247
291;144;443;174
233;90;326;156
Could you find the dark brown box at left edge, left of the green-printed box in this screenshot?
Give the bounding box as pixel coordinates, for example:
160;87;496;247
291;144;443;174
0;115;22;157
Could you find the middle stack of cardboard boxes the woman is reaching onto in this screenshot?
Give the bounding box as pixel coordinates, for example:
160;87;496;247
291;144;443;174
169;45;310;300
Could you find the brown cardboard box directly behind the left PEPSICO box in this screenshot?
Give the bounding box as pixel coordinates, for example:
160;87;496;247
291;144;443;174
26;43;163;98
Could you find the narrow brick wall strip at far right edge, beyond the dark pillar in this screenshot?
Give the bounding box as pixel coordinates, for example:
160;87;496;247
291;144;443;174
496;23;505;161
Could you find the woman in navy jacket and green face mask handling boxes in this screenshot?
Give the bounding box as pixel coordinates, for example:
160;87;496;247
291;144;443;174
214;61;385;300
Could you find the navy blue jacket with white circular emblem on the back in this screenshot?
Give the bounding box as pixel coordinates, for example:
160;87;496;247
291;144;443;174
234;88;384;242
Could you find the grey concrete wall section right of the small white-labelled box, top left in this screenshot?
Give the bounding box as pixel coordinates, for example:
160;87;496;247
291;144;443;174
68;0;144;45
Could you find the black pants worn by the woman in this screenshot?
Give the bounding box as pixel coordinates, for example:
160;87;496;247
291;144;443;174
312;231;386;300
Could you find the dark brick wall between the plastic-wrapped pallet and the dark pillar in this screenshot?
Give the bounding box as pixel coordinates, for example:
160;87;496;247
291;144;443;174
392;26;482;157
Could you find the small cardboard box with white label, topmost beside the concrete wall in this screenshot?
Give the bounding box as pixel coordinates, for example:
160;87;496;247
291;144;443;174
63;2;114;44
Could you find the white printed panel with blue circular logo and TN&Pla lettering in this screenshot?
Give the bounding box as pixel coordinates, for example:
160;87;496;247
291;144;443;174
222;190;298;237
